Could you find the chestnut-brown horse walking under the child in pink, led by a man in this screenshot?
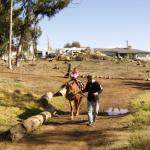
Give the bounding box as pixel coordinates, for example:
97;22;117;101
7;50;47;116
54;79;83;120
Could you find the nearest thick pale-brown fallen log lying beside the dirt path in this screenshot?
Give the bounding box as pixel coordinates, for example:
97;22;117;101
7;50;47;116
6;111;51;142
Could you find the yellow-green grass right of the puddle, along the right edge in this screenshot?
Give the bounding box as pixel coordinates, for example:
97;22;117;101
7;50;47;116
125;91;150;150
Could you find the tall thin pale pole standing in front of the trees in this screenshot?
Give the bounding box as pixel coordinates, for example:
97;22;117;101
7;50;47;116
8;0;13;69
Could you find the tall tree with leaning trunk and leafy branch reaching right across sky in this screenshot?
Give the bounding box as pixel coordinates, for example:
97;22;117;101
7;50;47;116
16;0;72;65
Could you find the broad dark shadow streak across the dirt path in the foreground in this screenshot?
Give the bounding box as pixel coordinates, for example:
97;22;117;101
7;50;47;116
21;124;126;147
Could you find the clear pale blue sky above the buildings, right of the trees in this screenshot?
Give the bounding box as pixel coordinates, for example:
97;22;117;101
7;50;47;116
38;0;150;51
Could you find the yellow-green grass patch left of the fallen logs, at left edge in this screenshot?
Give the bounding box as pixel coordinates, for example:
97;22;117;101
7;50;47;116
0;79;38;131
